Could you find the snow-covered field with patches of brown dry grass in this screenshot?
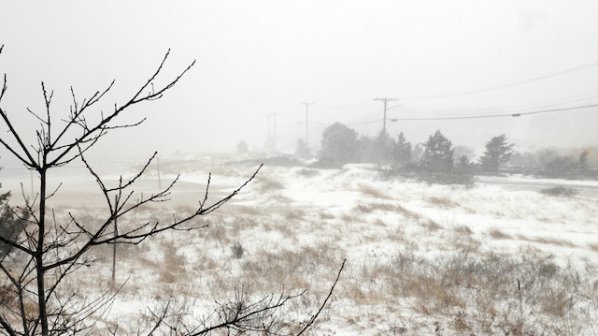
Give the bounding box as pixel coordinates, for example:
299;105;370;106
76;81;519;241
4;159;598;335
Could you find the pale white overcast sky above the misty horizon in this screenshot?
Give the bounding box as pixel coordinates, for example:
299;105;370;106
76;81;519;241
0;0;598;157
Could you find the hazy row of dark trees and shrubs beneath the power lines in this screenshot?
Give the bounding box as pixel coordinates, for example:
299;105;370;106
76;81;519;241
312;123;598;178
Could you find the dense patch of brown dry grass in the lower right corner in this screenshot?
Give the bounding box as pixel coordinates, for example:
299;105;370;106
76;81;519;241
368;250;598;335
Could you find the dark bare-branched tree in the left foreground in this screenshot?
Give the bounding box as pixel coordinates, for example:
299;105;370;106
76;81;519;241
0;47;342;336
